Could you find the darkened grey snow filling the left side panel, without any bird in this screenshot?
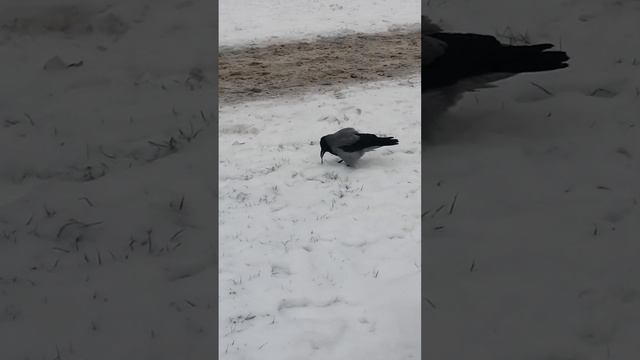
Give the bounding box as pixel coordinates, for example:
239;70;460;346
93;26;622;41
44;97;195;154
0;0;217;360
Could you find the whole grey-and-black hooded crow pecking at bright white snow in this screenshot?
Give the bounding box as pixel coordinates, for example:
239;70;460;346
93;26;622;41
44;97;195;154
320;128;398;166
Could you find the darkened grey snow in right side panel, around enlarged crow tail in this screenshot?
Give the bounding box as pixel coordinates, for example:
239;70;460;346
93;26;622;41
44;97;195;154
422;0;640;360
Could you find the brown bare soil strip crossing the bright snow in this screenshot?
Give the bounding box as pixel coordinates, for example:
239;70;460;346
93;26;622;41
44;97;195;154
218;31;420;104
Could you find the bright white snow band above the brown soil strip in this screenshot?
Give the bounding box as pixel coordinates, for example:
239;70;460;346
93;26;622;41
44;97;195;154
219;0;420;46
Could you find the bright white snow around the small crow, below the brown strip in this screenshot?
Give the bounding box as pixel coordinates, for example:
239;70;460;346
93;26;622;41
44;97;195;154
219;75;421;359
